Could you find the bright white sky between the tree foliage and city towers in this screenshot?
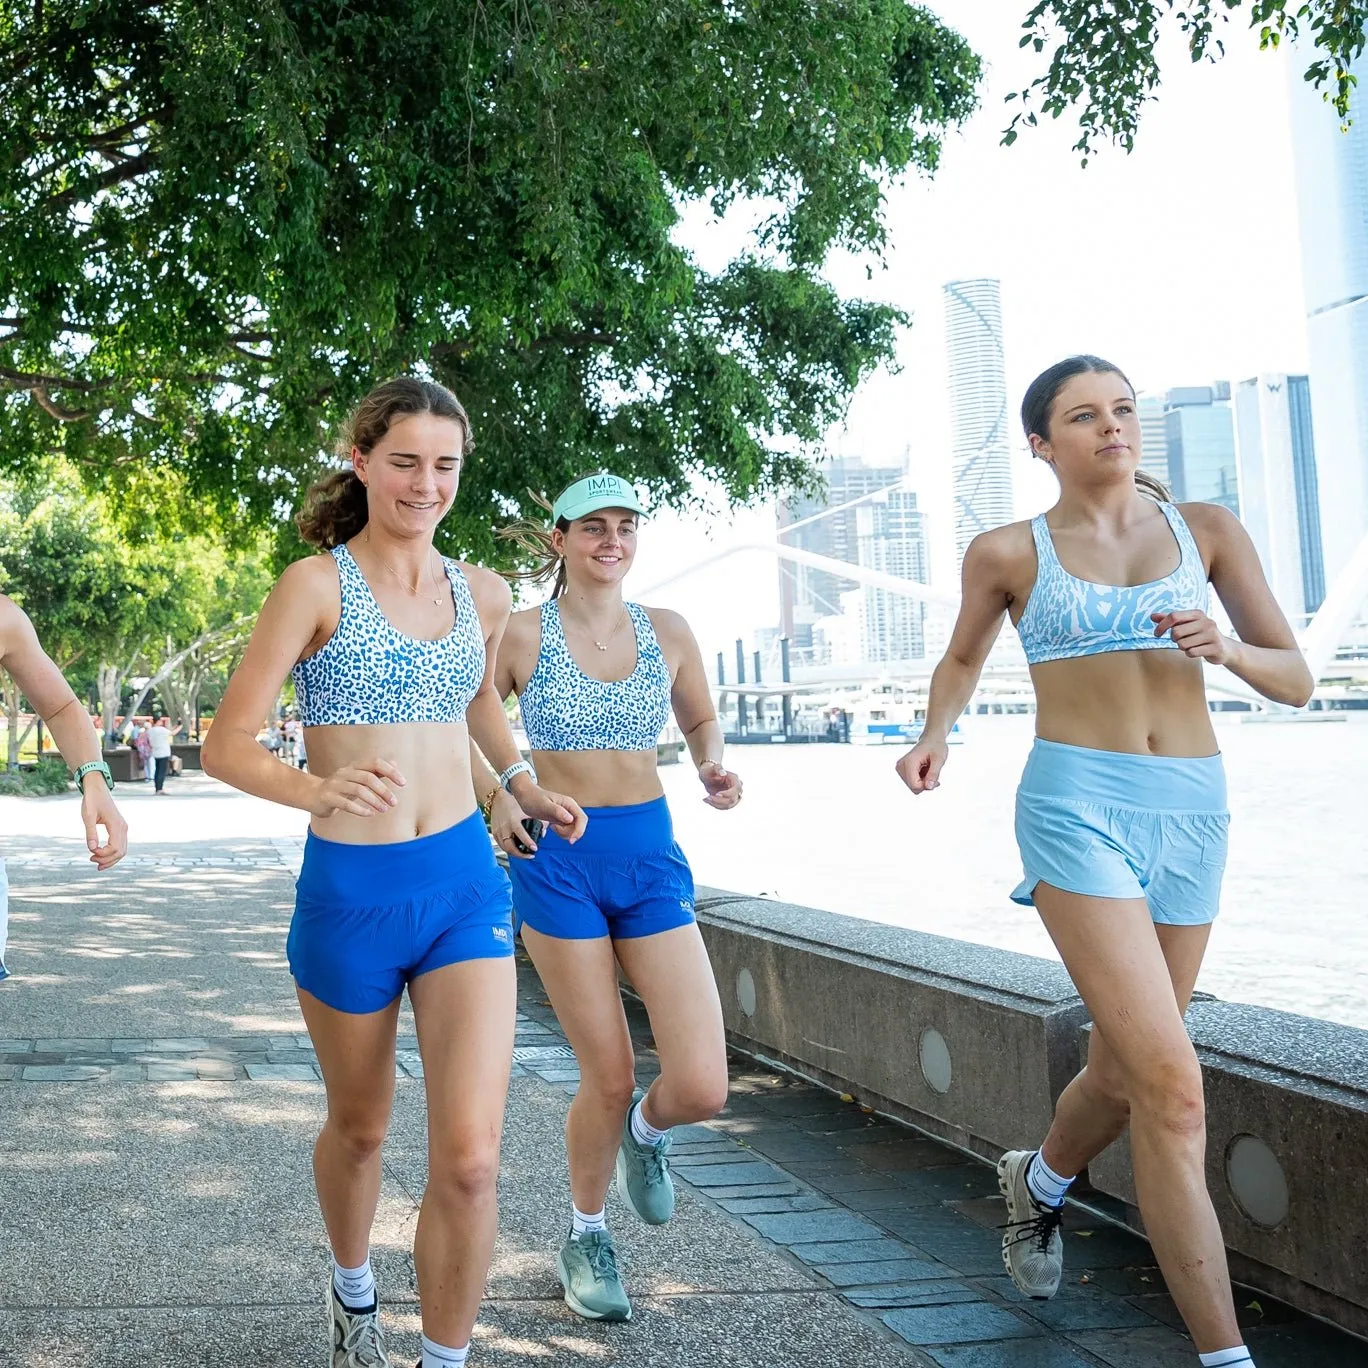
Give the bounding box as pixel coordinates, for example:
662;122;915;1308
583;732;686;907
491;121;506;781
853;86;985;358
628;0;1306;661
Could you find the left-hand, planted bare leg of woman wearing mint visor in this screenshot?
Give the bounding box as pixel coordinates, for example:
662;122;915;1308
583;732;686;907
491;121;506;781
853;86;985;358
523;925;635;1213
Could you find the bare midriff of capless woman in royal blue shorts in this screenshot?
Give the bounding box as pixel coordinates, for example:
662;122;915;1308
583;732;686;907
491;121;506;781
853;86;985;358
304;722;475;845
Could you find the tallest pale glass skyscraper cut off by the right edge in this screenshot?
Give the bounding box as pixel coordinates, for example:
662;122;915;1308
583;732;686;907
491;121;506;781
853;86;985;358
1289;62;1368;583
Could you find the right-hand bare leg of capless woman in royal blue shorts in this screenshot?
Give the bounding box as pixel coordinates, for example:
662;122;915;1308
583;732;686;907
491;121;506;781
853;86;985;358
409;956;517;1365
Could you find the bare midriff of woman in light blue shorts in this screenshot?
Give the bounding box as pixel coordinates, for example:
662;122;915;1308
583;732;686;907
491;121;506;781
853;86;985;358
1030;650;1218;757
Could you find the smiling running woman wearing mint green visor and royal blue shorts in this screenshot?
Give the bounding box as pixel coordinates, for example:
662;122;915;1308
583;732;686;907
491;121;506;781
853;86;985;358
489;475;741;1320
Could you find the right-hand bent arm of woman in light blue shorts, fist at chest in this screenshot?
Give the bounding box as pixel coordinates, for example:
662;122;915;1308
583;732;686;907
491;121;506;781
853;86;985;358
1153;503;1316;707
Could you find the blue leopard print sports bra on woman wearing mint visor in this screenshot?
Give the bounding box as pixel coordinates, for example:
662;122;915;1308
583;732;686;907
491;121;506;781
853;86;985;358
520;599;670;751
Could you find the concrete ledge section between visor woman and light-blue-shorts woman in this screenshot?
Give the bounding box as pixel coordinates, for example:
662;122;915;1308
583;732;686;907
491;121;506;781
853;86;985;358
698;889;1086;1159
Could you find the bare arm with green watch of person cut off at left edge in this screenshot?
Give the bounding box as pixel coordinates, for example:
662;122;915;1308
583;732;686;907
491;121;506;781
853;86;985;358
0;594;129;869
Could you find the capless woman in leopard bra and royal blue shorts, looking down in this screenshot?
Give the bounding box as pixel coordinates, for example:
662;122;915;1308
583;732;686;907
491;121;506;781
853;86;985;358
204;379;584;1368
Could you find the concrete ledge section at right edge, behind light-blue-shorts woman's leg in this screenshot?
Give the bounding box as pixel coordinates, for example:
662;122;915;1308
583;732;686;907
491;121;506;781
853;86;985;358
1083;1001;1368;1337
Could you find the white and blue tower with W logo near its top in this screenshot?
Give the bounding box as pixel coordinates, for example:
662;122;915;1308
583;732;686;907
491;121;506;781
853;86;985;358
1235;375;1324;622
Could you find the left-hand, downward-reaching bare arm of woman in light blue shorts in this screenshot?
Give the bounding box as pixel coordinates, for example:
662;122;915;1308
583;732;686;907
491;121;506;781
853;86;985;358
897;528;1010;793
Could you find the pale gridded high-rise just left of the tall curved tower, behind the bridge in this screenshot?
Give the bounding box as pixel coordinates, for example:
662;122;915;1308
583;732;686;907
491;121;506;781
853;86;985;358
855;490;926;661
